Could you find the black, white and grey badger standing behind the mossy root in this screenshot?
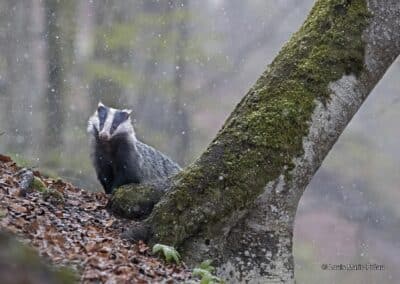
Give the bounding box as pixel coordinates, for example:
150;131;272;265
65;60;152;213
87;102;181;194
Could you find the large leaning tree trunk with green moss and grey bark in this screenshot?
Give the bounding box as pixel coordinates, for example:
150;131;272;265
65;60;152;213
112;0;400;283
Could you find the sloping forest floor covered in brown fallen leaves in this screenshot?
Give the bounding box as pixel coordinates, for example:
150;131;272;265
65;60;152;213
0;155;191;283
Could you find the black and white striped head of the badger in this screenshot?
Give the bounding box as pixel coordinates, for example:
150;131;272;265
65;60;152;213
87;102;135;141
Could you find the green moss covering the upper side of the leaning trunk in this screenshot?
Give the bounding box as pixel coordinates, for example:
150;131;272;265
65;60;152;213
146;0;369;245
